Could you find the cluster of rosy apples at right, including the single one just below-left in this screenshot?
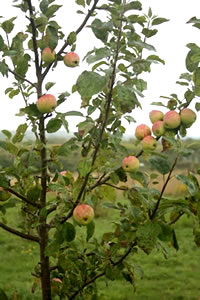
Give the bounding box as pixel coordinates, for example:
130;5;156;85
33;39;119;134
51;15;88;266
122;108;196;172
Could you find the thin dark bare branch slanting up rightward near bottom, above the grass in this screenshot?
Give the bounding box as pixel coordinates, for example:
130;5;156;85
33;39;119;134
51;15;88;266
69;242;137;300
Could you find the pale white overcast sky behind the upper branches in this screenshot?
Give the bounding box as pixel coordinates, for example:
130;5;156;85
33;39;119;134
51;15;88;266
0;0;200;138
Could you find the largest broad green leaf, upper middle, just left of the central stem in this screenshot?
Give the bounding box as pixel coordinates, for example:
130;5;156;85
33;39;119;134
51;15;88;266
76;71;107;98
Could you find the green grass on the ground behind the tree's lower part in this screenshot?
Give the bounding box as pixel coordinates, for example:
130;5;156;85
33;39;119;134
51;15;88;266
0;203;200;300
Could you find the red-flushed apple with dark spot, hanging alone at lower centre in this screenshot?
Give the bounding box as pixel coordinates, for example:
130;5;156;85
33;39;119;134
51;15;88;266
73;204;94;225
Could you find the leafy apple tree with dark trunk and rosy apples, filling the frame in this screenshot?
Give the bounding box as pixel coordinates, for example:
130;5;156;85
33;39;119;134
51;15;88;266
0;0;200;300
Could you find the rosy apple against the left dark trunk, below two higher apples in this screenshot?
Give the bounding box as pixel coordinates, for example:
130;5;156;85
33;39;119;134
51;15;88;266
36;94;57;113
